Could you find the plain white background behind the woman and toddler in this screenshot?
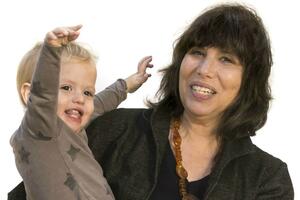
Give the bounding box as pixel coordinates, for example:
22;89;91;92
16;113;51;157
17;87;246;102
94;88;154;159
0;0;300;199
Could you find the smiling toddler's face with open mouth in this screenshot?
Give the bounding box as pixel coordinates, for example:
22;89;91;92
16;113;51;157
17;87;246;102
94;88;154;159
57;59;96;133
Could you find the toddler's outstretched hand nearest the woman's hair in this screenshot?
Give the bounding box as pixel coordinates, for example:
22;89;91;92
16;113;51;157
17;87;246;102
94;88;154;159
125;56;153;93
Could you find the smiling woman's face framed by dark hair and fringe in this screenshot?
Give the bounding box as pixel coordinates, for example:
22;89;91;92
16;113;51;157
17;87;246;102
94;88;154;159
179;47;243;122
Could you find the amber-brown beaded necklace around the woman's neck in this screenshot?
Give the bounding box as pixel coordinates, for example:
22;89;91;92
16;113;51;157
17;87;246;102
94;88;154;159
172;119;197;200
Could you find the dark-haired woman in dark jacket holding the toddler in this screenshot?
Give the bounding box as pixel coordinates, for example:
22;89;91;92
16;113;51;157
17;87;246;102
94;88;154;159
7;4;294;200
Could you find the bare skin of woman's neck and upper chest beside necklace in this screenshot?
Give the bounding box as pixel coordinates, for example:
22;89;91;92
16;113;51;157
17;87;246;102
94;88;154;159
170;116;220;181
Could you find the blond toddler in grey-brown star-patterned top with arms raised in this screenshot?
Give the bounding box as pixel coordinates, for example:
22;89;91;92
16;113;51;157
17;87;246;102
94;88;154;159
10;25;152;200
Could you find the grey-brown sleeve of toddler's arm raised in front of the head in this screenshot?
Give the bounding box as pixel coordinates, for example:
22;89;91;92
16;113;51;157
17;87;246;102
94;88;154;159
20;44;62;140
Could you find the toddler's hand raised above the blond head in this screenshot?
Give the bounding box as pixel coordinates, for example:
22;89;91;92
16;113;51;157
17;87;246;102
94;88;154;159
45;25;82;47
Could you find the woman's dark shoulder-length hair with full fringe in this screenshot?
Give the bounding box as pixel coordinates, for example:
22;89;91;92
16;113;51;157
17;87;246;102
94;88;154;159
150;4;272;139
